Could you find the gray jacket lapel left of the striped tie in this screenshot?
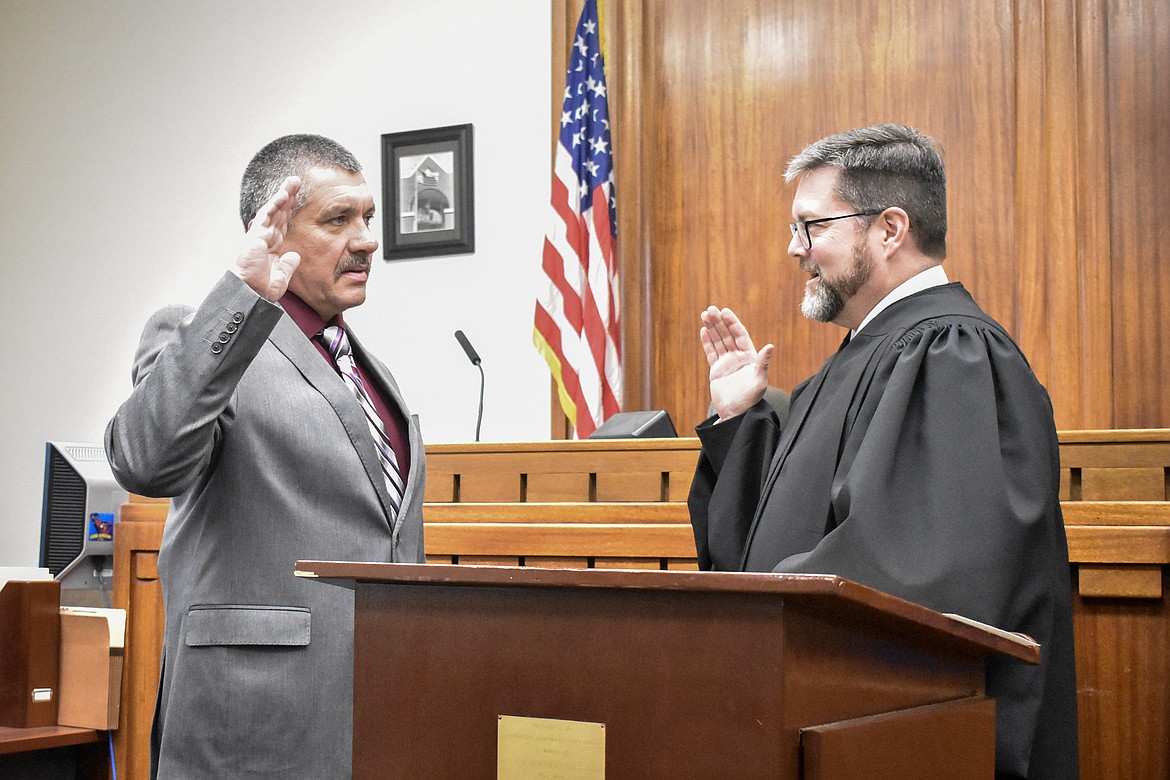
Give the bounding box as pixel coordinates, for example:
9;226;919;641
268;315;391;524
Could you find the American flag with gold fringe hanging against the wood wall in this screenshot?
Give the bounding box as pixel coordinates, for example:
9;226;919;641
532;0;621;439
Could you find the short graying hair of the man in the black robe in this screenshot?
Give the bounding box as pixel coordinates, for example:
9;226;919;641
784;124;947;260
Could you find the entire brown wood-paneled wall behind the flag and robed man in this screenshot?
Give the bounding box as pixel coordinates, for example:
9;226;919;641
552;0;1170;433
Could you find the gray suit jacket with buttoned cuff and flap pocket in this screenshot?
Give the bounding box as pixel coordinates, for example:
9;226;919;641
105;274;426;780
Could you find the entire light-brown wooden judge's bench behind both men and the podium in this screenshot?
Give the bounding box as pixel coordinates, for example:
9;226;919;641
115;430;1170;780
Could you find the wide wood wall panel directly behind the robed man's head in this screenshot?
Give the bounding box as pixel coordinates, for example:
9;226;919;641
611;0;1017;430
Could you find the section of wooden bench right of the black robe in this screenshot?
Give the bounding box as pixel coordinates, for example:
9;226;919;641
1060;430;1170;780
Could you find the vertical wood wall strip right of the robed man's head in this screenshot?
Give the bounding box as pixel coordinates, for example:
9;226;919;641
1010;0;1114;428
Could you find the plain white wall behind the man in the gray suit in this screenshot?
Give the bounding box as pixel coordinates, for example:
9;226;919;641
0;0;550;565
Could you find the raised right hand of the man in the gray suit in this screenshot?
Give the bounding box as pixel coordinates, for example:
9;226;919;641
232;177;301;302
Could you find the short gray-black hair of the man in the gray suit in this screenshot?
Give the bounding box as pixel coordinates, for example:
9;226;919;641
240;133;362;229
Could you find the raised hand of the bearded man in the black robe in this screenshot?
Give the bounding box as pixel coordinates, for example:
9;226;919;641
698;306;775;420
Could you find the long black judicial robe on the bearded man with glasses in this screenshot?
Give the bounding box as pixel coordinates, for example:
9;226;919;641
688;283;1078;778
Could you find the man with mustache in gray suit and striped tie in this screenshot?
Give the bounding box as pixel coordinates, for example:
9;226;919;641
105;136;425;780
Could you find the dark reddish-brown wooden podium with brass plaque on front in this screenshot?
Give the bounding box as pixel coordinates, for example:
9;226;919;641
296;561;1039;780
